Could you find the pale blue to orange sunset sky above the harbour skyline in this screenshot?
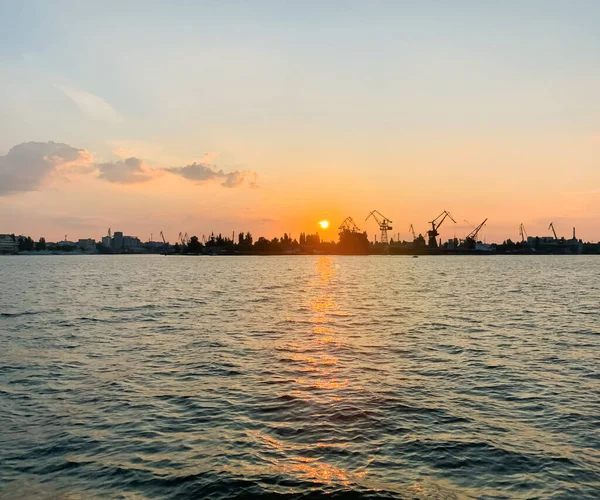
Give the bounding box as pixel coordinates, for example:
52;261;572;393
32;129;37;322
0;0;600;242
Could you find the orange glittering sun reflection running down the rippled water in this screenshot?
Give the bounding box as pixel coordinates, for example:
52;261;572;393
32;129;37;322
258;256;366;486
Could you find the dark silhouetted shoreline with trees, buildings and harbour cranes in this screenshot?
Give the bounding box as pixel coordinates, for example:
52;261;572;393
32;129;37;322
0;210;600;255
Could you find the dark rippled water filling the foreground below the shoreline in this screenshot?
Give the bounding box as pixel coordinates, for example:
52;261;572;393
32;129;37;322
0;256;600;499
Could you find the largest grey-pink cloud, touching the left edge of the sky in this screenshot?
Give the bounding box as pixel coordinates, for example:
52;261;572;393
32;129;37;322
0;142;93;196
